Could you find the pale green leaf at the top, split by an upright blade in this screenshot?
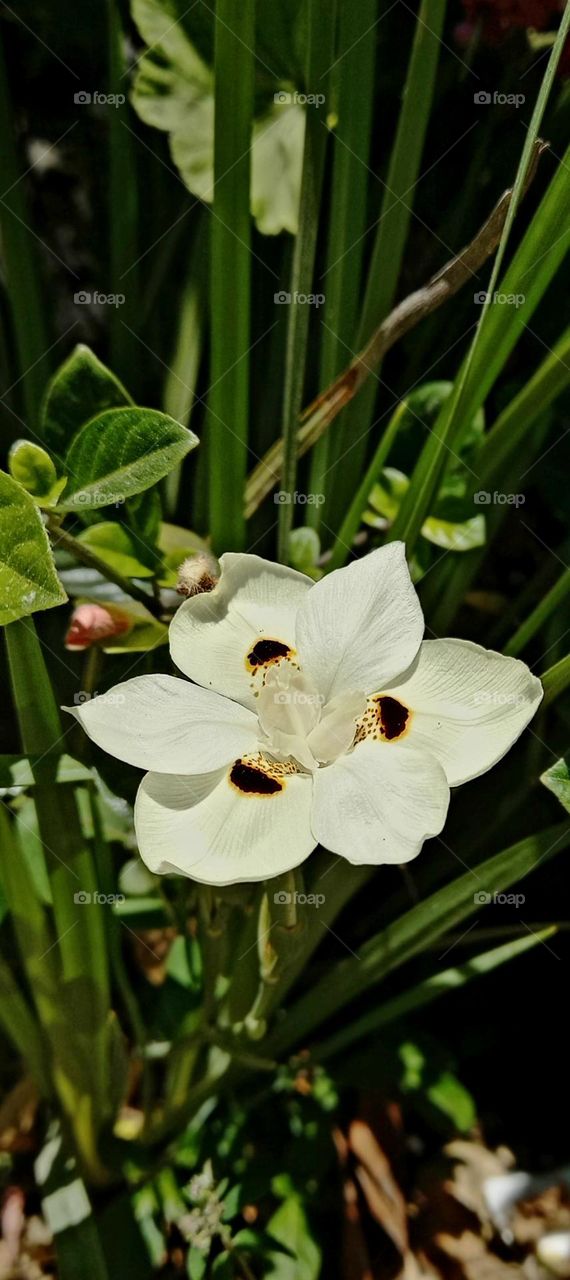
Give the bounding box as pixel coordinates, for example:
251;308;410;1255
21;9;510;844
132;0;305;236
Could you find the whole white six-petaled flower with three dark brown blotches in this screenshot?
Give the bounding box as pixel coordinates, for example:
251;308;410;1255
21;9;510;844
69;543;542;884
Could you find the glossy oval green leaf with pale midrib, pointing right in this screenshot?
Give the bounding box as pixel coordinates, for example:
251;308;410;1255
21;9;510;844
60;407;199;511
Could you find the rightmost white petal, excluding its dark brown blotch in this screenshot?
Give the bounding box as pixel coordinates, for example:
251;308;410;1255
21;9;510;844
387;640;543;786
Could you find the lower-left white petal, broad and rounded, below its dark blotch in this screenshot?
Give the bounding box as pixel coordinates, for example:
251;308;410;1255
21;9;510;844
134;769;316;884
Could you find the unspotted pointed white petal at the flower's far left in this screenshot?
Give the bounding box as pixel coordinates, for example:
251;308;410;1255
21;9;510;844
65;676;259;773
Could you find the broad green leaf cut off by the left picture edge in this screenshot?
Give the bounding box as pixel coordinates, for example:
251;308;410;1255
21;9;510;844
0;472;67;626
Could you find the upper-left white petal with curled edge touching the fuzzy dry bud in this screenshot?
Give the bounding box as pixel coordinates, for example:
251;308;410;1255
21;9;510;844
170;552;314;707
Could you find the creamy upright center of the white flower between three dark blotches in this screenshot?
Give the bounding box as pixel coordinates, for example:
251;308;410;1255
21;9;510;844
257;662;366;772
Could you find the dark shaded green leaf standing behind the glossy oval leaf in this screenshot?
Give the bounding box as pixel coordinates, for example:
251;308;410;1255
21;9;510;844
41;344;132;456
